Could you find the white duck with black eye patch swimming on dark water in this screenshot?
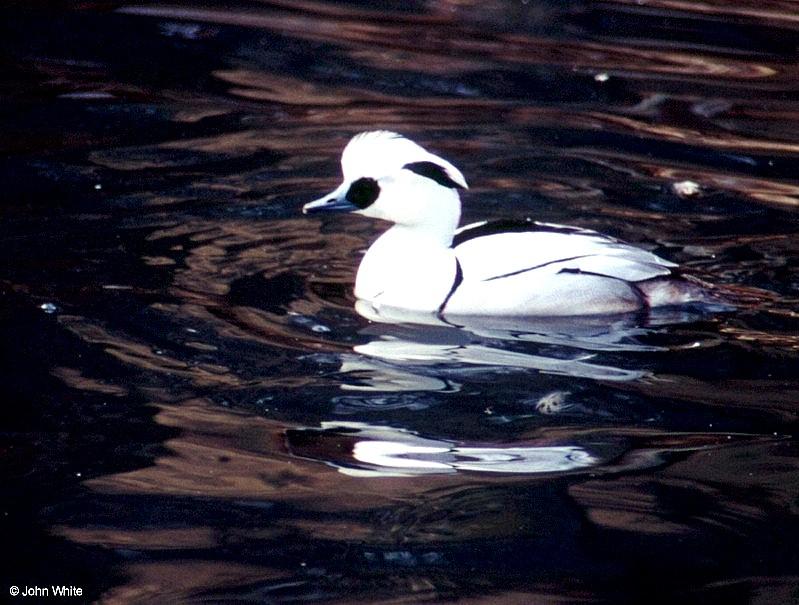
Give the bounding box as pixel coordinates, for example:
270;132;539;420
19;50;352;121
302;130;714;317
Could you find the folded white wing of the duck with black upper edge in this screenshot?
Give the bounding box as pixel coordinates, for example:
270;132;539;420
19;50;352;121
452;220;677;282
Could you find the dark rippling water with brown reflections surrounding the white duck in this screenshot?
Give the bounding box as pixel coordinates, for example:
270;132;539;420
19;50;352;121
0;0;799;604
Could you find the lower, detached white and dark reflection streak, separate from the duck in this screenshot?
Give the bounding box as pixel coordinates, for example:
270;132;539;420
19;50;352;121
285;421;781;478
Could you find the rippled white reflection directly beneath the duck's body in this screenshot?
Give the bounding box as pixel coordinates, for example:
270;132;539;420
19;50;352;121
328;301;720;391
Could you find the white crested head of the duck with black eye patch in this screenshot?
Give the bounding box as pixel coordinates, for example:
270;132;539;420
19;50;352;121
302;130;468;232
